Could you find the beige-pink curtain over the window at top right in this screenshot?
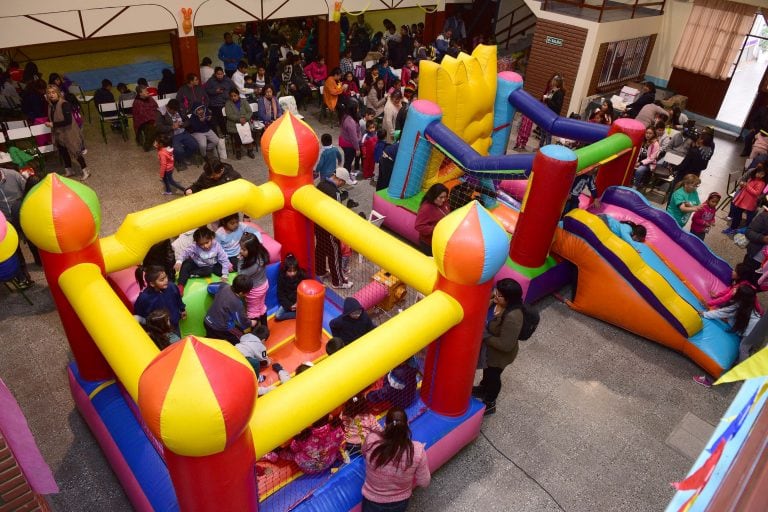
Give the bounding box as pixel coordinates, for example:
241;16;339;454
672;0;757;80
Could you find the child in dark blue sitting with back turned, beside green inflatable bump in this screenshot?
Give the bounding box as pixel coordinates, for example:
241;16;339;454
203;276;256;345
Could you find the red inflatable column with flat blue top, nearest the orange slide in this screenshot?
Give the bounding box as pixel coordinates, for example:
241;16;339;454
509;145;576;268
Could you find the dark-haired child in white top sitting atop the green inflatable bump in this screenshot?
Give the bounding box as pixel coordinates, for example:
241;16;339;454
173;226;229;290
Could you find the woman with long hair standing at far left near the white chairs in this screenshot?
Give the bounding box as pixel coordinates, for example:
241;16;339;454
45;85;91;181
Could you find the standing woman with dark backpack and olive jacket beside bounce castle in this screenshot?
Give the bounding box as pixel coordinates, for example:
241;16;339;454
472;277;523;415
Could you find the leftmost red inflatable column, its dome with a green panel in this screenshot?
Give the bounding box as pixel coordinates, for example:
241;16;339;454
21;174;112;380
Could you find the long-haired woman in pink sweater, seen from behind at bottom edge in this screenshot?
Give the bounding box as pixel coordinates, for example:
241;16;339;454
362;407;431;512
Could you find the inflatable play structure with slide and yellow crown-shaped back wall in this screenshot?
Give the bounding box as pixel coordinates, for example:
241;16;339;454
373;45;738;376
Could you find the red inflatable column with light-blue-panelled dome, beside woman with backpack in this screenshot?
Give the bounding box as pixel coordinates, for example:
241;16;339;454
421;201;509;416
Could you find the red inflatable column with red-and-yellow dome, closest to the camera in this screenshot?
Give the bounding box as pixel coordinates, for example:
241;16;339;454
139;336;259;512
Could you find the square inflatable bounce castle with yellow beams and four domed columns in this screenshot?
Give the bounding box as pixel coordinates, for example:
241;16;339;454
21;113;509;511
